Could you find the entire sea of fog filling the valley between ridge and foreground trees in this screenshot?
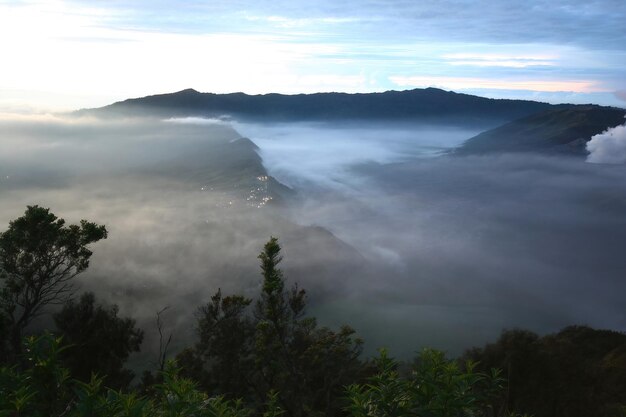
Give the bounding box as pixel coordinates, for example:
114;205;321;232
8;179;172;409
0;117;626;360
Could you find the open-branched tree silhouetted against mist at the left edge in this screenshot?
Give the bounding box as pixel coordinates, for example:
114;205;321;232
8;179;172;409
0;206;107;354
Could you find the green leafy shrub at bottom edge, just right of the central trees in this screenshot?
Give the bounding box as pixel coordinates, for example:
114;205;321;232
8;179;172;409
346;349;504;417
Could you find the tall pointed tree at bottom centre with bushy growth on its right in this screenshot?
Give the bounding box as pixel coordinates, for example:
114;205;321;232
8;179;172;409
254;237;363;417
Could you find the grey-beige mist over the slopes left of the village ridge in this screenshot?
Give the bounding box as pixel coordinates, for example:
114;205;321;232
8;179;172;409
0;116;370;366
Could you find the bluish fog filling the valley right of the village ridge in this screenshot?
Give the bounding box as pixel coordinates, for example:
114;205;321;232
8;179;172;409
236;118;626;357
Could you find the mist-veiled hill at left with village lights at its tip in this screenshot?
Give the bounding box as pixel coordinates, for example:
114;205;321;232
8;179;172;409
0;118;293;207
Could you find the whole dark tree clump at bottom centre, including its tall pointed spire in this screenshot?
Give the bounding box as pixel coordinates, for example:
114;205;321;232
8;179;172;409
183;238;363;417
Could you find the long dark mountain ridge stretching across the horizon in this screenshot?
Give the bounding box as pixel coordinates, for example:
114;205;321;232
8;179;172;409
75;88;553;126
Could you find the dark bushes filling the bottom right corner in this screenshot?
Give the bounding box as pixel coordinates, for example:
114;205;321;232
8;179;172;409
465;326;626;417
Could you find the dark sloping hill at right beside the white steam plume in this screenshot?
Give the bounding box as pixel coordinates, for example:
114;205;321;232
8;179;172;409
453;105;626;155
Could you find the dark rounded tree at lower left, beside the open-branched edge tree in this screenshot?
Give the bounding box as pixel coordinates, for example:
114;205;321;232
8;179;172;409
53;292;143;389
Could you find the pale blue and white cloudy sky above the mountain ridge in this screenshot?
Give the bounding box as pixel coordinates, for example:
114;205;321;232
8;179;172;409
0;0;626;113
